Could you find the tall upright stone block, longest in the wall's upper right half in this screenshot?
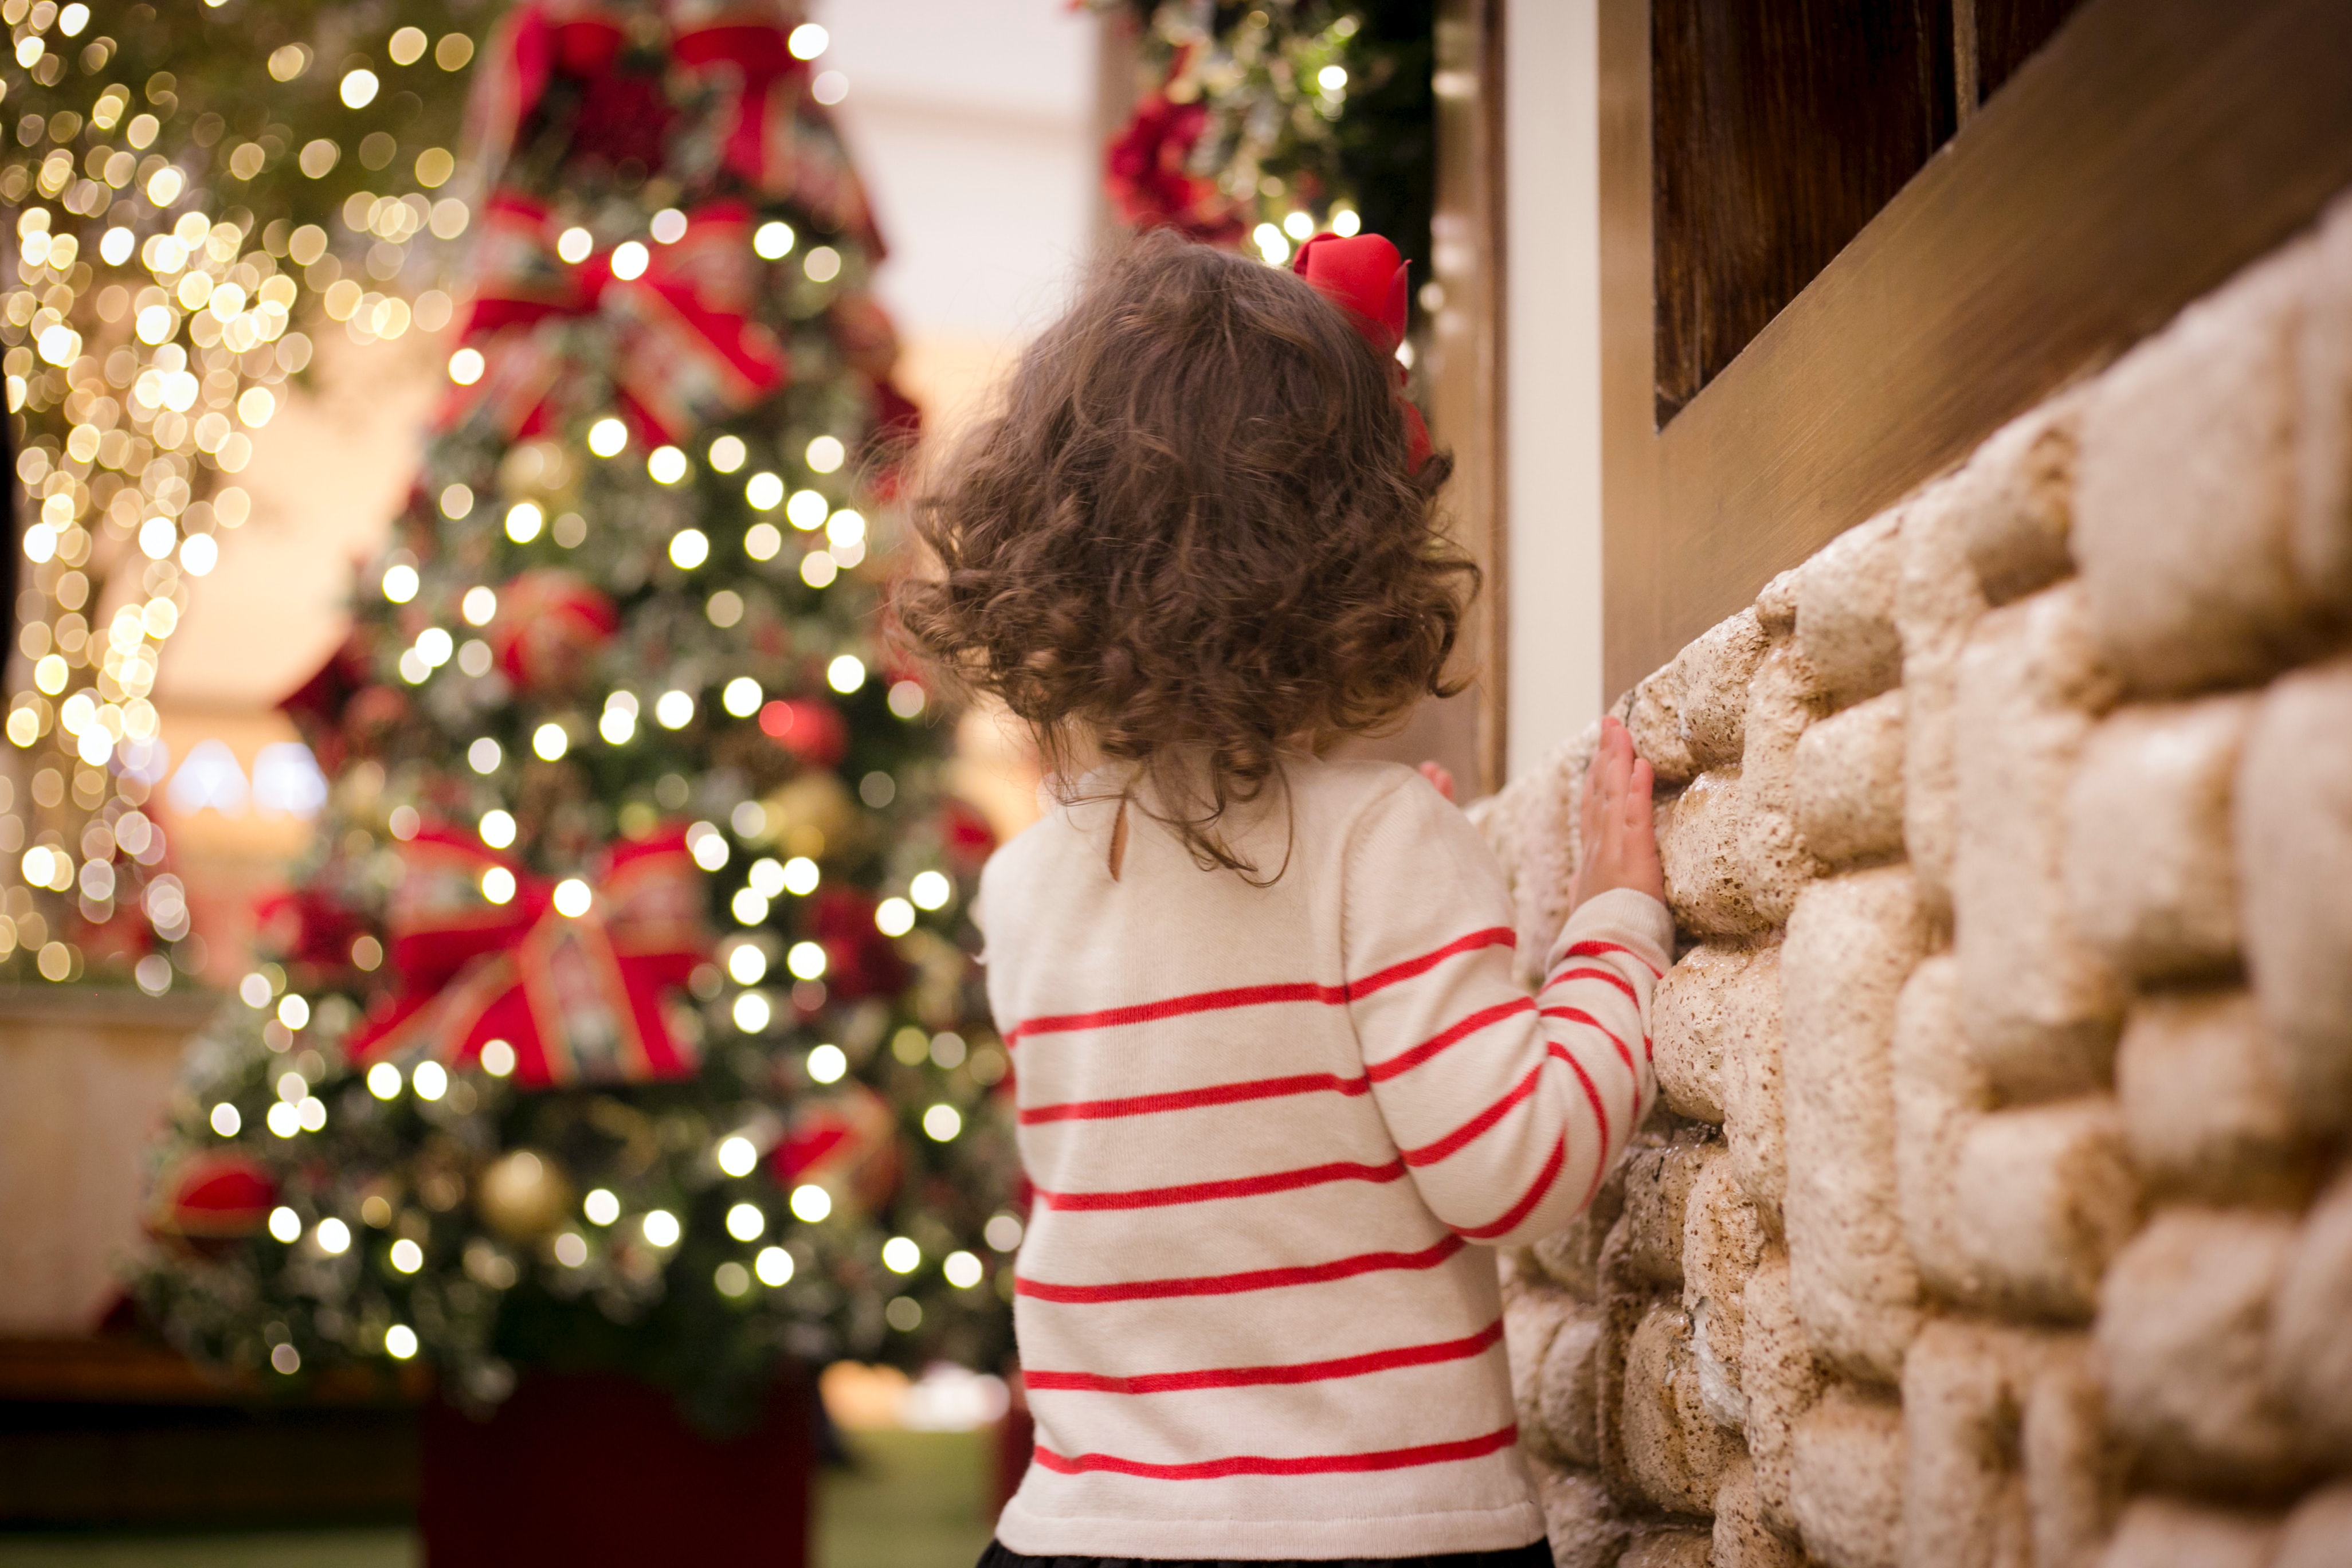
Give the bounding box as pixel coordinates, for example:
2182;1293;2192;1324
1952;583;2124;1098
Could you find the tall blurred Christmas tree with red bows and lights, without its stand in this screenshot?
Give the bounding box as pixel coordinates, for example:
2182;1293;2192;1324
136;0;1018;1425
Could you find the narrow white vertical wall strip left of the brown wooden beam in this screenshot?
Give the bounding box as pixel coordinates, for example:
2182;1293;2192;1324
1503;0;1604;774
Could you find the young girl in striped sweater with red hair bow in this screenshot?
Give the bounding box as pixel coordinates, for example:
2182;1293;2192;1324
901;235;1672;1568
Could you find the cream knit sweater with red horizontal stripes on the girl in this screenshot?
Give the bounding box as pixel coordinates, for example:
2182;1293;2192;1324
978;762;1672;1559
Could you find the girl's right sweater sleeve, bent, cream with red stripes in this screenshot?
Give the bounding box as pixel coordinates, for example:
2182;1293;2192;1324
1340;778;1675;1246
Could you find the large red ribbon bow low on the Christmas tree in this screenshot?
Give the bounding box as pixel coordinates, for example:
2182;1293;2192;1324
343;828;708;1088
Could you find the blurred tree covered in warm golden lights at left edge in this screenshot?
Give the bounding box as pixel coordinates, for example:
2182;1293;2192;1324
0;0;480;992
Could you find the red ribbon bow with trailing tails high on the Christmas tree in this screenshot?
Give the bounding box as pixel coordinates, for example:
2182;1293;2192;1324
440;190;790;442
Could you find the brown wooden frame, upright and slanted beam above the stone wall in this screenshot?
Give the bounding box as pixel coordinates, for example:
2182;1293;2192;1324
1600;0;2352;693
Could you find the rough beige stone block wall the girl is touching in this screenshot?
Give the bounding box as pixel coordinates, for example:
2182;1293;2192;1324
1477;209;2352;1568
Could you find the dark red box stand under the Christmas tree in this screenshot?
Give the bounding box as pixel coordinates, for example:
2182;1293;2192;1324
416;1375;816;1568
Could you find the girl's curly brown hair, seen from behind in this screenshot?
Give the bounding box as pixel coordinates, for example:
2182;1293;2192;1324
896;233;1477;879
